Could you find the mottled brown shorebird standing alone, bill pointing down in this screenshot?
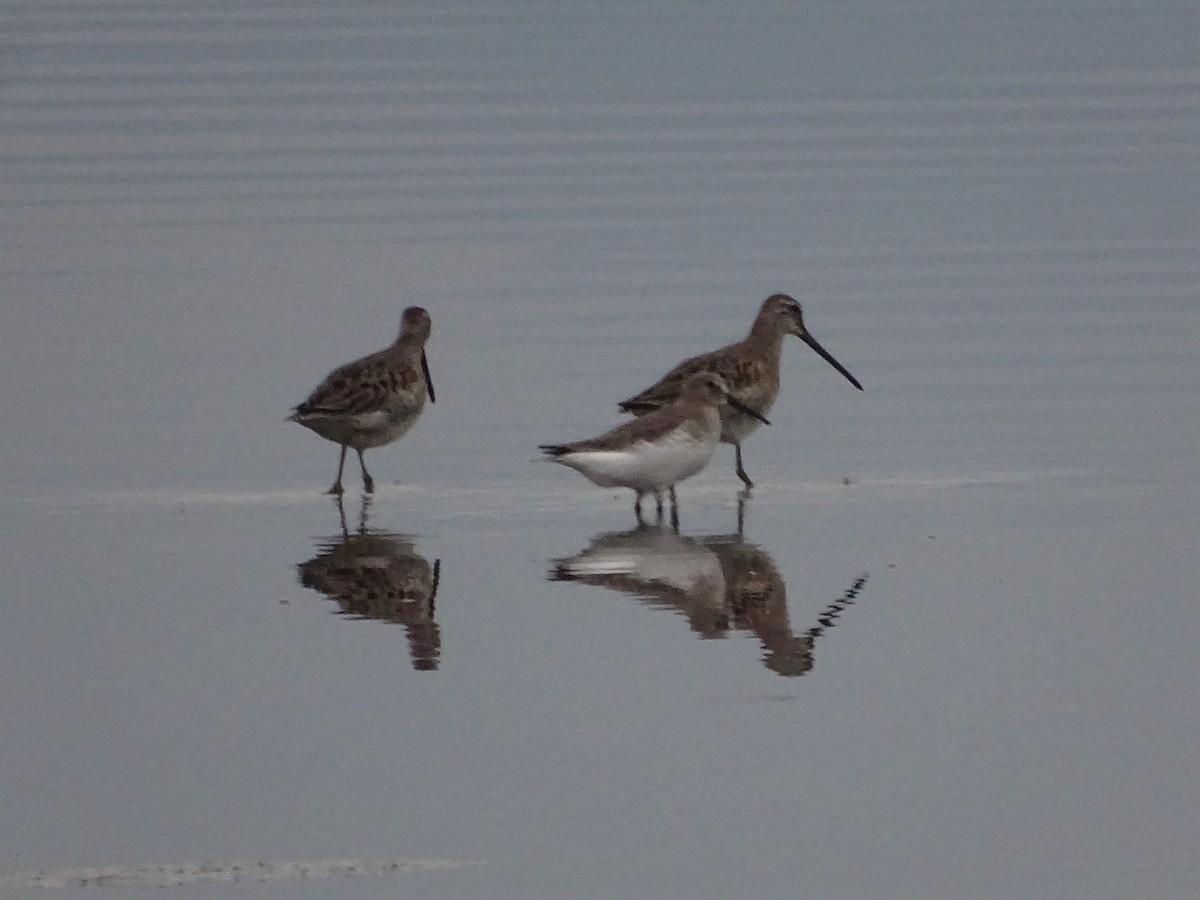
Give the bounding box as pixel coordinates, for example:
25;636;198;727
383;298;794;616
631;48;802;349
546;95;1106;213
288;306;434;494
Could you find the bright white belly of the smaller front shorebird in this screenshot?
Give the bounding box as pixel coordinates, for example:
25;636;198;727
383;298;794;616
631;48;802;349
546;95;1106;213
559;427;716;491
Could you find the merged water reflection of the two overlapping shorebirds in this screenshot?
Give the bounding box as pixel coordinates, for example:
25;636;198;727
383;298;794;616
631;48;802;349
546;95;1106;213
548;526;866;677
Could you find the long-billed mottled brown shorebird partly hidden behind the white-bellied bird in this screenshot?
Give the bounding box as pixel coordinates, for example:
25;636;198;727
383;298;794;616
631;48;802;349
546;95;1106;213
618;294;863;488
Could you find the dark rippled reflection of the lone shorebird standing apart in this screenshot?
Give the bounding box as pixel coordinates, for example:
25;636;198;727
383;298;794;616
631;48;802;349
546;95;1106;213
296;494;442;671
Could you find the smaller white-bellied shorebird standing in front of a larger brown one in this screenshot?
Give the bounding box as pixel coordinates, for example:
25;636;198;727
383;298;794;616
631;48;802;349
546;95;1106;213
539;372;770;518
